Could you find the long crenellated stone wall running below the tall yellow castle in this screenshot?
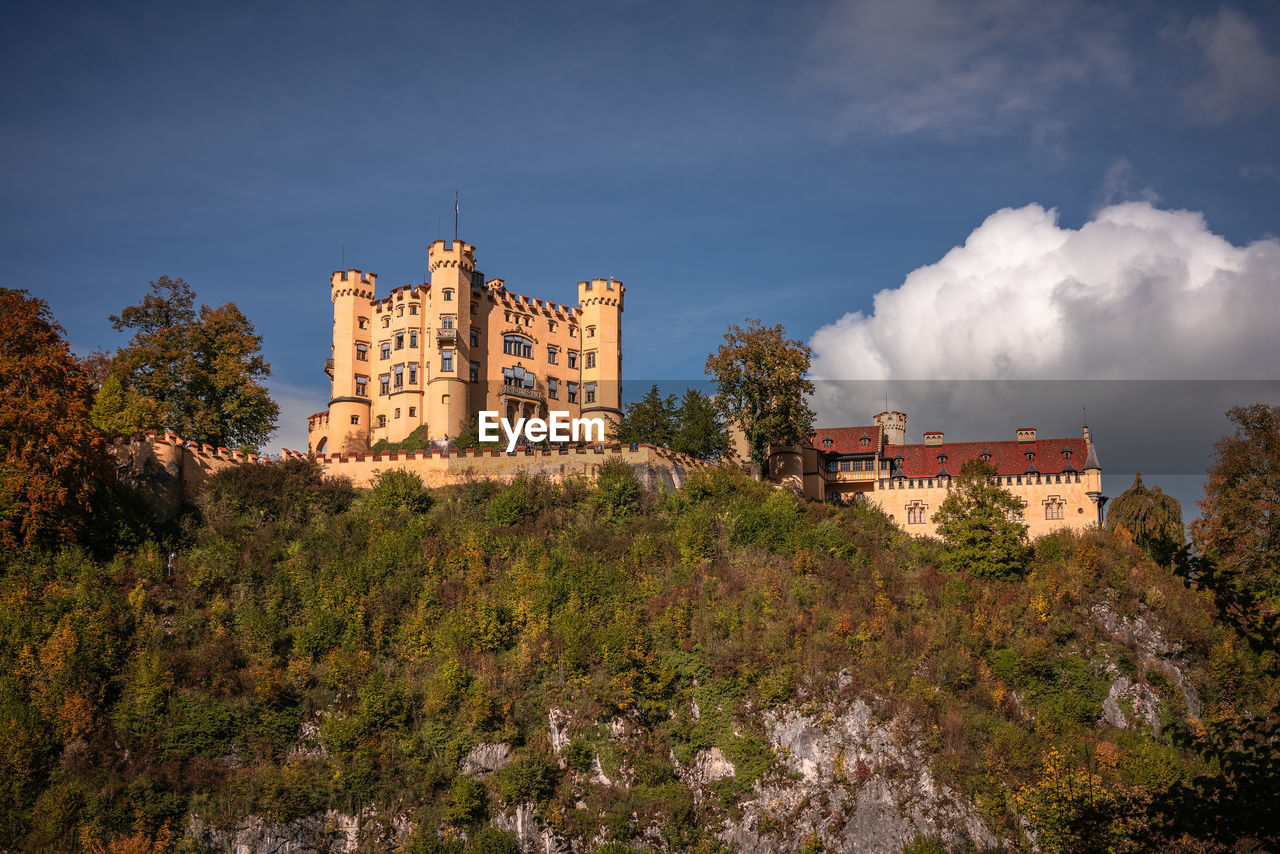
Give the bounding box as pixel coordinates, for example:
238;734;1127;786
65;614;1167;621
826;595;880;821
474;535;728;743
113;431;705;519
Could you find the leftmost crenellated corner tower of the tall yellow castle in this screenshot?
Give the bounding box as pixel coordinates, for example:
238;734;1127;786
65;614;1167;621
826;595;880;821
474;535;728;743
321;270;378;453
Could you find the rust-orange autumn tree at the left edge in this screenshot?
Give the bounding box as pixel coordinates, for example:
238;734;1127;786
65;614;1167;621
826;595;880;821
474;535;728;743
0;288;110;548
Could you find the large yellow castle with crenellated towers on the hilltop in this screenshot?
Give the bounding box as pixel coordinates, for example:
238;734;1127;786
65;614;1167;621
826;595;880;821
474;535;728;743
307;241;626;455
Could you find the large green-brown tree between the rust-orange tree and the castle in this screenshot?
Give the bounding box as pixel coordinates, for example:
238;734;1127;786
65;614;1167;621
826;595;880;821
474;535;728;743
111;277;279;449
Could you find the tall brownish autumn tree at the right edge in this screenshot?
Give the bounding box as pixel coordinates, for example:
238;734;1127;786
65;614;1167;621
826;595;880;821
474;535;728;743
1192;403;1280;617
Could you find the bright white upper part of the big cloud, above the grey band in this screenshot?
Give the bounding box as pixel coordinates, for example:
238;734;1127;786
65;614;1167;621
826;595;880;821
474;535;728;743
810;202;1280;423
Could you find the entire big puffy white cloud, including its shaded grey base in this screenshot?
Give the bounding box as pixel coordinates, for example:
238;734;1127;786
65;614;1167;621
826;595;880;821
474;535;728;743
810;202;1280;471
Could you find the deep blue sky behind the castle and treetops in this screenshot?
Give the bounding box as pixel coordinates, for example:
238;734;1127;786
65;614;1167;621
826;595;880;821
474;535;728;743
0;0;1280;501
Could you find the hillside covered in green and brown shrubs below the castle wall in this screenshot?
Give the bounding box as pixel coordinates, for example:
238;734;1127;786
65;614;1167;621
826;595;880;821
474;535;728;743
0;462;1280;853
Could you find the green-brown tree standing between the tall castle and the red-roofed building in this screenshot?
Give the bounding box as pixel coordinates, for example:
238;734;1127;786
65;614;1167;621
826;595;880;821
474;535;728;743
707;319;814;471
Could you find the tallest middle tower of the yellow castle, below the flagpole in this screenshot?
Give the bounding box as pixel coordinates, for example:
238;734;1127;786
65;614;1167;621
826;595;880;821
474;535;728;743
422;241;476;439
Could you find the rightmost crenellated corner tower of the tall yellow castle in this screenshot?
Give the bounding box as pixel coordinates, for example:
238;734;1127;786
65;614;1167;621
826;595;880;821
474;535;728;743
577;279;627;435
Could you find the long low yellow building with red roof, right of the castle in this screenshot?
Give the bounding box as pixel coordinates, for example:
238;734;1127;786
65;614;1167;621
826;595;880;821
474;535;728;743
768;411;1106;536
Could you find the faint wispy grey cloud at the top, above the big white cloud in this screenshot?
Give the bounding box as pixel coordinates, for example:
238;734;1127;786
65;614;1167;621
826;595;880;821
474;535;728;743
813;0;1128;134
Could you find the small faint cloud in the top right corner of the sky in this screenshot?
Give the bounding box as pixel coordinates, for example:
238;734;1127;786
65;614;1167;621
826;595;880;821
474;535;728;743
1183;6;1280;124
